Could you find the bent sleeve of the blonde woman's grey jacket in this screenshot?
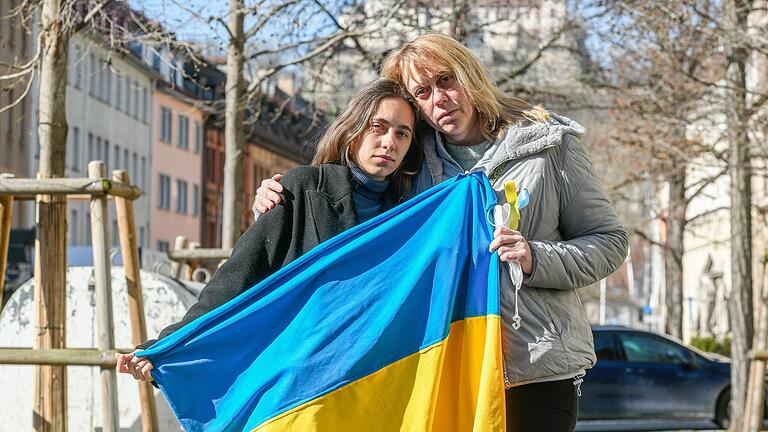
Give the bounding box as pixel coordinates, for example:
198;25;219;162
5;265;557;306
523;135;629;289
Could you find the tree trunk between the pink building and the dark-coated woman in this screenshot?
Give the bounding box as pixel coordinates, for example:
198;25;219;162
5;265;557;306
221;0;245;249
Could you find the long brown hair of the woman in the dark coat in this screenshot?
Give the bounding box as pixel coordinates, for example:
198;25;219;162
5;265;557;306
312;78;423;202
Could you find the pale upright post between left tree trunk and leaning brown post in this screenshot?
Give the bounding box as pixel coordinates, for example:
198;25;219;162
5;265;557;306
88;161;120;432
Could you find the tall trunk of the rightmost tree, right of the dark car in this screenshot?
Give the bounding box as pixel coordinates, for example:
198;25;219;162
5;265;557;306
725;0;754;430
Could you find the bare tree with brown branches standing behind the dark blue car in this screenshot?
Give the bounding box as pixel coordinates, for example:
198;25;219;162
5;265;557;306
591;2;724;338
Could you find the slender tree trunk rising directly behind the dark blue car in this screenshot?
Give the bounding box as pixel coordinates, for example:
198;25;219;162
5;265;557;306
664;164;686;339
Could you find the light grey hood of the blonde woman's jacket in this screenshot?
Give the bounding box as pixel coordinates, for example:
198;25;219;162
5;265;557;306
486;113;587;167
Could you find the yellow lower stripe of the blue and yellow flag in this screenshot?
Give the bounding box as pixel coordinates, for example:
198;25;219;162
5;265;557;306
253;315;505;432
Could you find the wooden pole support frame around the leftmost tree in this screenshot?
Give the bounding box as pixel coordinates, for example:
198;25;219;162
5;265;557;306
0;161;158;432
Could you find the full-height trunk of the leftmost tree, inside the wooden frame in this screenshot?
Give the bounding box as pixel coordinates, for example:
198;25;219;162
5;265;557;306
33;0;68;431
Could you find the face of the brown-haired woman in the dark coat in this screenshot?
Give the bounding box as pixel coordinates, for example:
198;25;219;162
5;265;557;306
352;98;415;181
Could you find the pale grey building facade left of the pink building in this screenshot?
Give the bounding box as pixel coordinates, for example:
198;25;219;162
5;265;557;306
41;32;159;247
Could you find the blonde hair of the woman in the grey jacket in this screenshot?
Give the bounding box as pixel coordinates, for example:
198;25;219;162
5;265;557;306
381;33;551;139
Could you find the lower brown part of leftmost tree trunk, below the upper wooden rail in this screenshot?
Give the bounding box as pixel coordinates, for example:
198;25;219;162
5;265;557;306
32;181;67;432
